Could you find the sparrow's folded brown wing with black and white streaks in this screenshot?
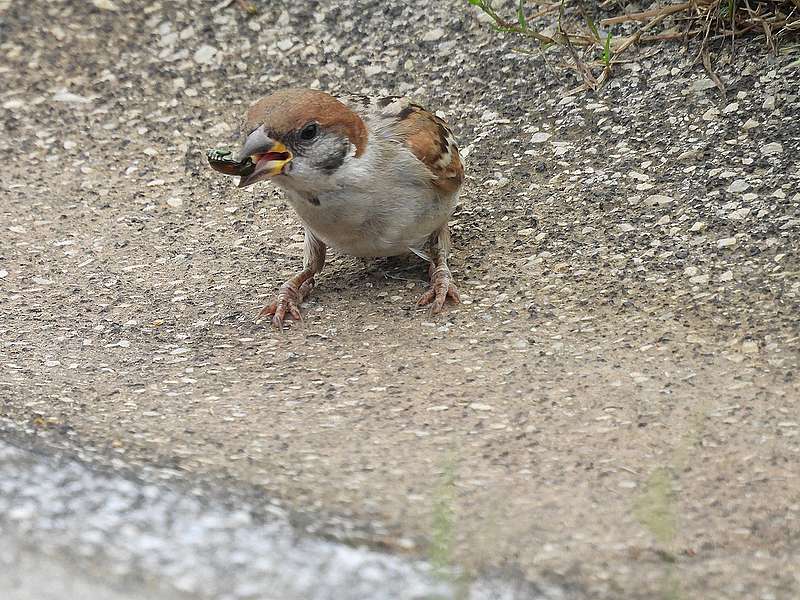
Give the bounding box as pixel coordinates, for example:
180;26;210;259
338;94;464;195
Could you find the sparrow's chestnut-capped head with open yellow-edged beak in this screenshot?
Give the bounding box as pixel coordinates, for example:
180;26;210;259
233;89;367;192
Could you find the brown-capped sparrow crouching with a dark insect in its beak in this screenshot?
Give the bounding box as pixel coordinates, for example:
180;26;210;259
209;88;464;327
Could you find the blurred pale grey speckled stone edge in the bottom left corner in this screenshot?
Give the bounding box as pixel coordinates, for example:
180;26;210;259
0;436;565;600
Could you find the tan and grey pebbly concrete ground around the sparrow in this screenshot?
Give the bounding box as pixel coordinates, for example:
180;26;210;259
0;0;800;600
